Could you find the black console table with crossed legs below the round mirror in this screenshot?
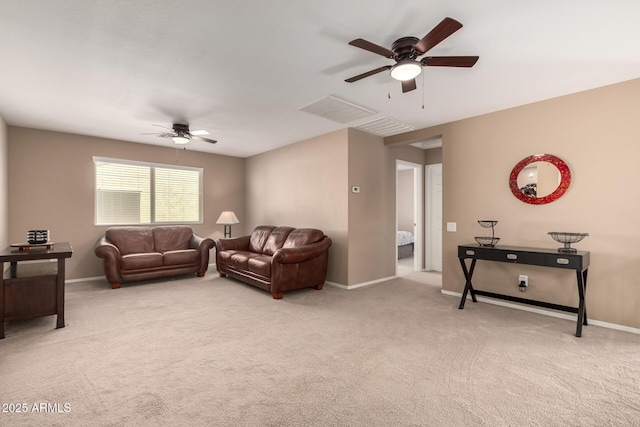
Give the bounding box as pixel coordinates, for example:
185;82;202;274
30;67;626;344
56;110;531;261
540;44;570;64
458;244;589;337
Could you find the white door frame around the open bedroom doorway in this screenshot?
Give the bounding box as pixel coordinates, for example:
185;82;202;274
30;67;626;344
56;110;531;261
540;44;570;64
394;159;424;275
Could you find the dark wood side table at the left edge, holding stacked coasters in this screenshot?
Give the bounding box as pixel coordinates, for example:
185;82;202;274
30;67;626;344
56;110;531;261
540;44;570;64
0;242;73;338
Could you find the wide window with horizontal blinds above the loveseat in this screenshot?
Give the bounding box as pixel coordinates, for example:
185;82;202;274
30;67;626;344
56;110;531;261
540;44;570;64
93;157;202;225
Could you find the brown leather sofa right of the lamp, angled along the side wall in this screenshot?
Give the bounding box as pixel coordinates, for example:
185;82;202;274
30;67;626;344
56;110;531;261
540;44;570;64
216;225;331;299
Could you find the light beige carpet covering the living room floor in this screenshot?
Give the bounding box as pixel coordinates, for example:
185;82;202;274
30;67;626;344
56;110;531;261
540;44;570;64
0;271;640;426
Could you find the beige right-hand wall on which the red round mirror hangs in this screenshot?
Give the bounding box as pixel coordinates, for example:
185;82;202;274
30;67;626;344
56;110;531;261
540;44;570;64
385;80;640;328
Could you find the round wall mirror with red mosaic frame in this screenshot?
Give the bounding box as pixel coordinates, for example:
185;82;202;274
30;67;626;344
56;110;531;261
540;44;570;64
509;154;571;205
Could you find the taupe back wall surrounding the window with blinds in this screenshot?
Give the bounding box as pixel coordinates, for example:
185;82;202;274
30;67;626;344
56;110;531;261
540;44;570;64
8;126;245;279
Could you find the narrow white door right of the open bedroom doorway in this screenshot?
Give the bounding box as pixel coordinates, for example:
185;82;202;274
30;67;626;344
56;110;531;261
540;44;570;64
425;163;442;271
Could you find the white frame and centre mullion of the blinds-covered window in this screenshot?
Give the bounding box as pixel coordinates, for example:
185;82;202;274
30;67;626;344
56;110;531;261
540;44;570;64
93;156;204;226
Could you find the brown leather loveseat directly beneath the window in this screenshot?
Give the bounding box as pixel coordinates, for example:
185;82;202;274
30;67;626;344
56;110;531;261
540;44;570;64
95;226;214;289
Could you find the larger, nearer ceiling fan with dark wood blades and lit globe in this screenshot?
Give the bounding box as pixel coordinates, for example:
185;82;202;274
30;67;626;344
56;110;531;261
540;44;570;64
345;17;479;92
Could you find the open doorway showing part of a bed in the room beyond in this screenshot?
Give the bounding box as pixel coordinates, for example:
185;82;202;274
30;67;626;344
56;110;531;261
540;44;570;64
396;160;424;275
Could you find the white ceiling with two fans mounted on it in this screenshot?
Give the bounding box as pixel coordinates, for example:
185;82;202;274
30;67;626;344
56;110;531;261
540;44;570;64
0;0;640;157
